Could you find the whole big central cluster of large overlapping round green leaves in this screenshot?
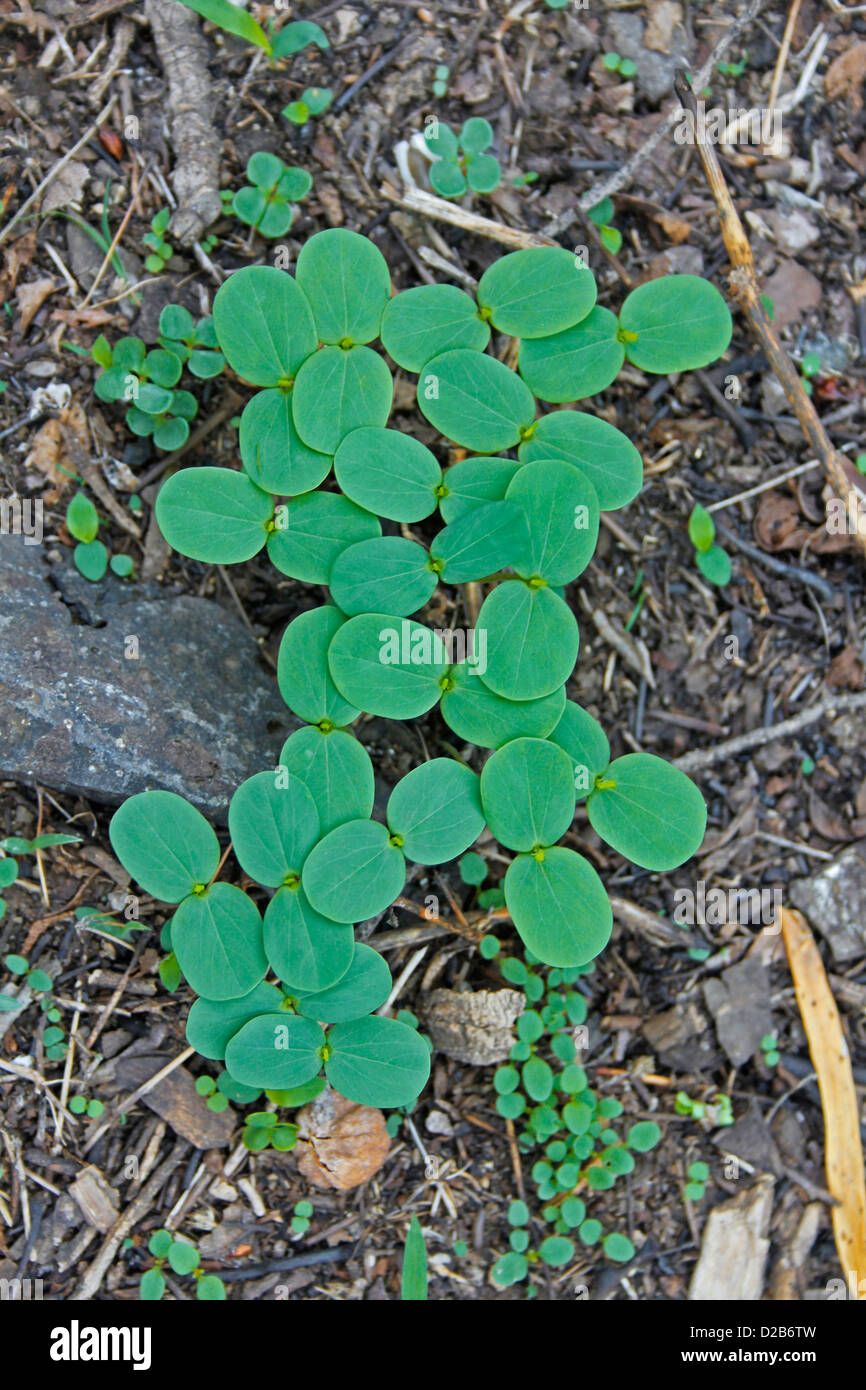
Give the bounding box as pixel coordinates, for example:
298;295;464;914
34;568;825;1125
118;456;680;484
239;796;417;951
104;228;731;1117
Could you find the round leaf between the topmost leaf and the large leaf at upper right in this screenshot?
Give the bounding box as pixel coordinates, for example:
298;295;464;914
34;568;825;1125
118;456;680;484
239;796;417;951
382;285;491;373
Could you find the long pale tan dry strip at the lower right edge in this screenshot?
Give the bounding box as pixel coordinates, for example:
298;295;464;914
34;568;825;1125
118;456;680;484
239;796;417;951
781;908;866;1300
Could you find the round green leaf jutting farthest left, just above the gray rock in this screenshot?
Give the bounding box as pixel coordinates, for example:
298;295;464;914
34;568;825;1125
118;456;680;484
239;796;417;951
156;467;274;564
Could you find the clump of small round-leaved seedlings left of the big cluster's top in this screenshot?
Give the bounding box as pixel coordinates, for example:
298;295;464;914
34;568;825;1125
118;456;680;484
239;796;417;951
92;330;200;450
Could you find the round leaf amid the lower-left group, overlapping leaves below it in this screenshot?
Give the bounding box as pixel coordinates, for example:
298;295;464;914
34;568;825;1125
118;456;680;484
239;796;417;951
302;820;406;922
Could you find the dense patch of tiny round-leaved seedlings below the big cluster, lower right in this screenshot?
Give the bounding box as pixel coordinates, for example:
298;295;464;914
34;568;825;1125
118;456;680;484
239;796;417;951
492;937;660;1283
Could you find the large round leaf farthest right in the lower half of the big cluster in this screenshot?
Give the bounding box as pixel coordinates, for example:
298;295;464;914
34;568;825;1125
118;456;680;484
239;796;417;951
587;753;706;872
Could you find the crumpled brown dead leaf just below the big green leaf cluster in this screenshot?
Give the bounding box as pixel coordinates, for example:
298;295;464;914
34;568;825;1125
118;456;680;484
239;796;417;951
295;1091;391;1193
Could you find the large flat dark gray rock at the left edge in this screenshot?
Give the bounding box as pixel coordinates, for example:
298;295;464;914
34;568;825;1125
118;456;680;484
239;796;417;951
0;535;299;820
